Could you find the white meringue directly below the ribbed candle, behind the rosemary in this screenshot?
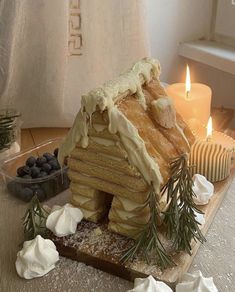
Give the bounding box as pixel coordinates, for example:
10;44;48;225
193;174;214;205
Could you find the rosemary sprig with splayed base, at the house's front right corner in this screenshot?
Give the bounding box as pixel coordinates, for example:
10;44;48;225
120;190;175;269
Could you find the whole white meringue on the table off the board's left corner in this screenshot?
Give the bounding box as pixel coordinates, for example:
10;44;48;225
15;235;59;279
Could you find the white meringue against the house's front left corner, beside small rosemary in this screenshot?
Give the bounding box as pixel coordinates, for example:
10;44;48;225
46;204;83;237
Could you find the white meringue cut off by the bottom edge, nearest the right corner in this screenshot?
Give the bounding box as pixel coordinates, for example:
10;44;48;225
176;271;218;292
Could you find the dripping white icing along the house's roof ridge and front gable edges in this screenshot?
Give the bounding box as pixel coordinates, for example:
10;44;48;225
59;58;169;193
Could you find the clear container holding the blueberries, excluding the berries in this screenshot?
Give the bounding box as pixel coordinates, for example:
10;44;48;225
0;138;70;202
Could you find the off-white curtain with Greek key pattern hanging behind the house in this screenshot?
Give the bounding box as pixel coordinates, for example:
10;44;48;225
0;0;149;127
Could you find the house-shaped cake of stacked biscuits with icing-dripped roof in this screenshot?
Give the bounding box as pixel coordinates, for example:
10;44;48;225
59;58;194;238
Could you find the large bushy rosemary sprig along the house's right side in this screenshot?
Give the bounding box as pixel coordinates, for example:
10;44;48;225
162;154;206;255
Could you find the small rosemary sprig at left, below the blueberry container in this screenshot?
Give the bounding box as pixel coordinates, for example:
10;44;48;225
22;195;48;240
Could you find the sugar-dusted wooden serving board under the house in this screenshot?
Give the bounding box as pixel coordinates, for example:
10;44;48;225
50;165;235;288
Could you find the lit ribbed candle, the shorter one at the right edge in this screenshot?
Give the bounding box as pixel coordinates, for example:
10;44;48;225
189;118;235;182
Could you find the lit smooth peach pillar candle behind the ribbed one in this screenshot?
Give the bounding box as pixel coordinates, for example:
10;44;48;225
166;66;211;125
